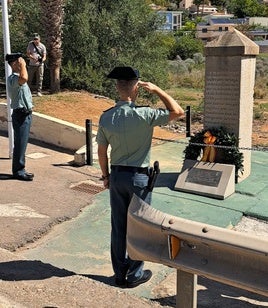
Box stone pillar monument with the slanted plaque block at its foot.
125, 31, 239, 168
175, 29, 259, 199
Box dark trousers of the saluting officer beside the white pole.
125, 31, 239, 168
12, 108, 32, 175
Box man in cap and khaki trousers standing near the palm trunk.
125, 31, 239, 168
27, 33, 47, 96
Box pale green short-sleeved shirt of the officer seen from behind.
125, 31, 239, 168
96, 101, 169, 167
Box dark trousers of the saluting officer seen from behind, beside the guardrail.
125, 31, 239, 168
110, 166, 152, 282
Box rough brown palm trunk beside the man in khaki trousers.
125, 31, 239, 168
40, 0, 64, 93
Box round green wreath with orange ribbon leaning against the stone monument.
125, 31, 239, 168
183, 127, 244, 182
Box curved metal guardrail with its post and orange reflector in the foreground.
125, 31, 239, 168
127, 195, 268, 308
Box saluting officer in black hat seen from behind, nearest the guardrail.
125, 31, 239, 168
96, 67, 184, 288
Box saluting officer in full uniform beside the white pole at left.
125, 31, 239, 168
6, 53, 34, 181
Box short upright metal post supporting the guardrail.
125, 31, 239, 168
176, 269, 197, 308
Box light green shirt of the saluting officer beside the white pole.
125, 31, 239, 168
7, 73, 33, 110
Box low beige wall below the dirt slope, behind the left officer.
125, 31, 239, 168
0, 103, 96, 151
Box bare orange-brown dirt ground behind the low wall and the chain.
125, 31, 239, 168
34, 91, 268, 146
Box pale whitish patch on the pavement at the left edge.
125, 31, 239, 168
0, 203, 49, 218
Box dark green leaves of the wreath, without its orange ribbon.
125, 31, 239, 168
183, 127, 244, 178
